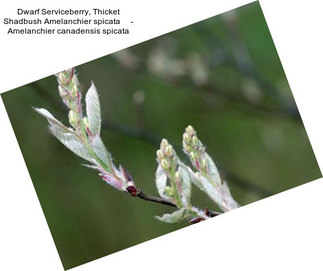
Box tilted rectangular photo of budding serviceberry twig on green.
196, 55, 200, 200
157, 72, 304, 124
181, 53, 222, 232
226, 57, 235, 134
1, 2, 322, 269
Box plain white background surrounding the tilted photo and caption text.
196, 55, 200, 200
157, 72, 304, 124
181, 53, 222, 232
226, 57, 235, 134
0, 0, 323, 270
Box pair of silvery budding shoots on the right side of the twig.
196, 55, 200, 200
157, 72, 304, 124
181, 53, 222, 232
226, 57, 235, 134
156, 125, 239, 223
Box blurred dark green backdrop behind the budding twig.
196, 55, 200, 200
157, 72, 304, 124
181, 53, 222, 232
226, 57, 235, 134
1, 2, 321, 269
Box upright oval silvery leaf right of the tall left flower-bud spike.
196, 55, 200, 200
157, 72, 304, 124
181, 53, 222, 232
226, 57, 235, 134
85, 82, 101, 135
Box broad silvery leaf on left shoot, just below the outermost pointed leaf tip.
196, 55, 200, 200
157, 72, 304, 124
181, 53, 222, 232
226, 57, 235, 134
49, 125, 93, 162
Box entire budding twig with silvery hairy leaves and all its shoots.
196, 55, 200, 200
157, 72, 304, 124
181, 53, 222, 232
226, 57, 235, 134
34, 68, 239, 223
